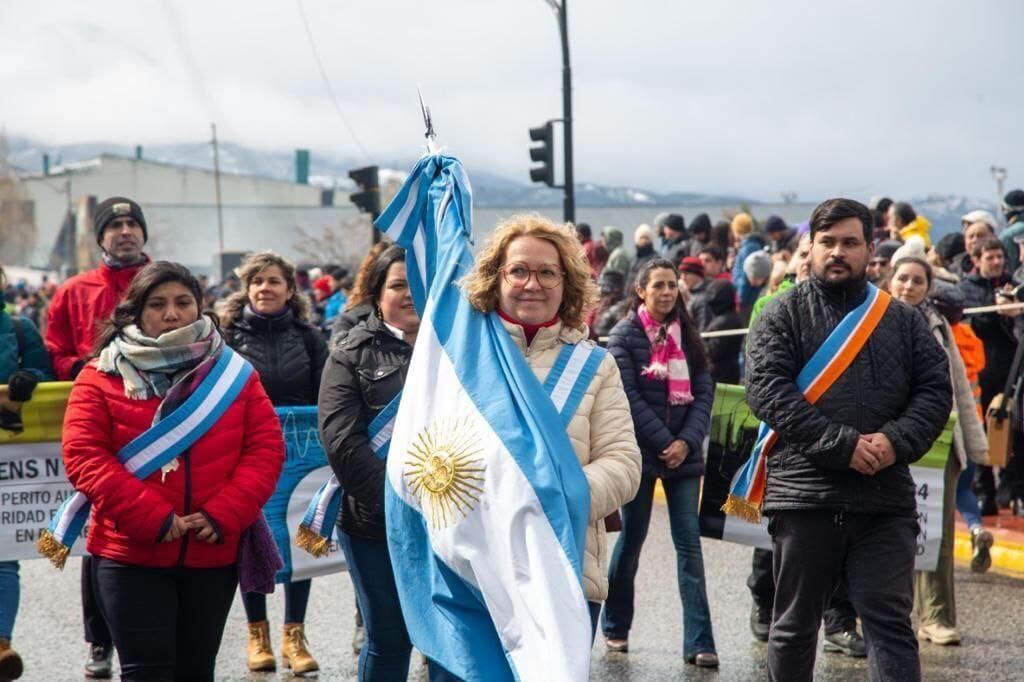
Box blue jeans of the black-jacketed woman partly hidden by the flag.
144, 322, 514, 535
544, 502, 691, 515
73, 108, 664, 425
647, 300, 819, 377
337, 528, 455, 682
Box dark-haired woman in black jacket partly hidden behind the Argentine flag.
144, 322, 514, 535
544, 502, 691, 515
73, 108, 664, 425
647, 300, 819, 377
319, 246, 446, 681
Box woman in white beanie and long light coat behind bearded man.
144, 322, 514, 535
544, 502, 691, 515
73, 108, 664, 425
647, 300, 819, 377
889, 256, 992, 645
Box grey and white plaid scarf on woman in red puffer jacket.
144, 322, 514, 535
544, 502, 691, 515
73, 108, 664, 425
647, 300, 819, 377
97, 315, 224, 403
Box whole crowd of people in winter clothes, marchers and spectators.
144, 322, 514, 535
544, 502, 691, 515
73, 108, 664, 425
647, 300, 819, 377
0, 190, 1024, 680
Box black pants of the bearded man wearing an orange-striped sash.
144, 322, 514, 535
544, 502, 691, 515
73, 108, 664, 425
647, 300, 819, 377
768, 510, 921, 682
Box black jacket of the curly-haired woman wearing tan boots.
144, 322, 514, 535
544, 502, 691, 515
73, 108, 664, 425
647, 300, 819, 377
224, 306, 327, 408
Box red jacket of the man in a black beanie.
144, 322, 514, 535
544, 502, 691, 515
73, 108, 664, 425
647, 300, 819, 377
46, 258, 150, 381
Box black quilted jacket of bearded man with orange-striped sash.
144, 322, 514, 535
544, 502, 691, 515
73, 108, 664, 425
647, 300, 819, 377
746, 276, 952, 514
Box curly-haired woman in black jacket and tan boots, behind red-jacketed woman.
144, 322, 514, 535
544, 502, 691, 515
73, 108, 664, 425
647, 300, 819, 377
218, 251, 327, 674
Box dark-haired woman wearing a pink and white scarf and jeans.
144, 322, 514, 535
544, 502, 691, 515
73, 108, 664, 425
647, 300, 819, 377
603, 258, 718, 668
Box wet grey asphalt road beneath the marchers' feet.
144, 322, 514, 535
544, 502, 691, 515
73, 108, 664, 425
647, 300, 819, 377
14, 497, 1024, 682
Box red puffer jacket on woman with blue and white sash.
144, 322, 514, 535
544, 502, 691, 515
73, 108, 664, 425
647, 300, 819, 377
63, 365, 285, 568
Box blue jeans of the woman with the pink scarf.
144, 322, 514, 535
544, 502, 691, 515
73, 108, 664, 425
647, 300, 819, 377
602, 475, 715, 660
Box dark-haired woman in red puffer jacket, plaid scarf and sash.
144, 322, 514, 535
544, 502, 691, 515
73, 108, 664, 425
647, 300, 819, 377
63, 261, 285, 680
